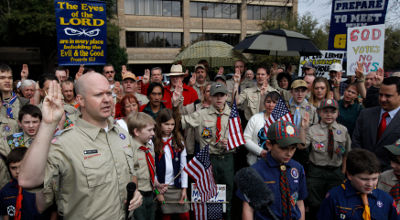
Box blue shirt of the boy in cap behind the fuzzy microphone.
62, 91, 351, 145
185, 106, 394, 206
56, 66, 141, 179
237, 152, 307, 220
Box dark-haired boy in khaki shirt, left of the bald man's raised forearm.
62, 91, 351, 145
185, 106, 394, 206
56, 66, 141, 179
0, 104, 42, 188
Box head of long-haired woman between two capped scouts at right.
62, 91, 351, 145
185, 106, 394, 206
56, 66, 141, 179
309, 77, 333, 108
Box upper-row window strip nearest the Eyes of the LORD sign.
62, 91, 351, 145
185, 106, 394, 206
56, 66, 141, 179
125, 0, 182, 17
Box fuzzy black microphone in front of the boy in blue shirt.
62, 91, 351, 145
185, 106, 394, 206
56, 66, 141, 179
235, 167, 279, 220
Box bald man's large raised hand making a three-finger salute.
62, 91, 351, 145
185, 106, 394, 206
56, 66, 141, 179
42, 81, 64, 125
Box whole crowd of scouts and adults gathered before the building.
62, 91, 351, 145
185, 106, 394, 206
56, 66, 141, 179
0, 60, 400, 220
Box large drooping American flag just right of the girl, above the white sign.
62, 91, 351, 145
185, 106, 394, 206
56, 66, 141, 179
183, 145, 217, 202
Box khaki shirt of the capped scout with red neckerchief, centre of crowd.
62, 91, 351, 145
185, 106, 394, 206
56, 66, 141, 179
182, 104, 231, 154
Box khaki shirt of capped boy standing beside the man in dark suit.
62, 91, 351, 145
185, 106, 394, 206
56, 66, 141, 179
306, 122, 351, 167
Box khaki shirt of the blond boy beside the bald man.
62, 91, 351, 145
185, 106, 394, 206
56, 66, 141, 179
132, 138, 156, 192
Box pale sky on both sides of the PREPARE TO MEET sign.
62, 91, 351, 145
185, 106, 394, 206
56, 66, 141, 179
298, 0, 400, 27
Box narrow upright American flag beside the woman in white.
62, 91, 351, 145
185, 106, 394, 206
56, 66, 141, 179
226, 101, 246, 150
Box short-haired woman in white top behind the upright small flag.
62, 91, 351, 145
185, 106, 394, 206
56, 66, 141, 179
244, 92, 280, 165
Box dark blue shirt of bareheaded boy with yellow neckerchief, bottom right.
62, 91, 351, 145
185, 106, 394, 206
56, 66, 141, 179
317, 181, 400, 220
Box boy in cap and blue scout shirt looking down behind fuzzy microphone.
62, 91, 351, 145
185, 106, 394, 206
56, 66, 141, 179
238, 121, 307, 220
